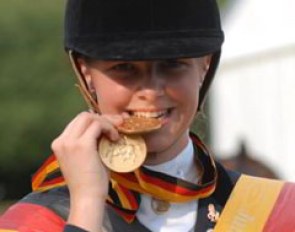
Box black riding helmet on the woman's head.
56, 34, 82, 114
64, 0, 224, 109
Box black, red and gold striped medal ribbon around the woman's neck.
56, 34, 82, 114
32, 133, 217, 222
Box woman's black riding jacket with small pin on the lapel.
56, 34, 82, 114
11, 163, 240, 232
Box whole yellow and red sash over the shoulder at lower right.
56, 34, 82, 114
214, 175, 295, 232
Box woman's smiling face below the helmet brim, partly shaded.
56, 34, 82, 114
79, 56, 211, 164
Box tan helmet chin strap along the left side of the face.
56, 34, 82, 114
69, 50, 100, 114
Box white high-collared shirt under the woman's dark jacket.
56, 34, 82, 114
136, 140, 198, 232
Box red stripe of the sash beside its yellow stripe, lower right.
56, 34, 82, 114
263, 183, 295, 232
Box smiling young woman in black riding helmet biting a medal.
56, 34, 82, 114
0, 0, 295, 232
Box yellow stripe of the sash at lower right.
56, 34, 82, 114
214, 175, 284, 232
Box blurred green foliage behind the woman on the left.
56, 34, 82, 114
0, 0, 84, 198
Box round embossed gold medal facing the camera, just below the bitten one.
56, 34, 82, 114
98, 135, 147, 172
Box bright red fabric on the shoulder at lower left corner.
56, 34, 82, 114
0, 203, 65, 232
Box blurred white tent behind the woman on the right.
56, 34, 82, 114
211, 0, 295, 181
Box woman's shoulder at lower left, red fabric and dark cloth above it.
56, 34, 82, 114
0, 187, 70, 232
